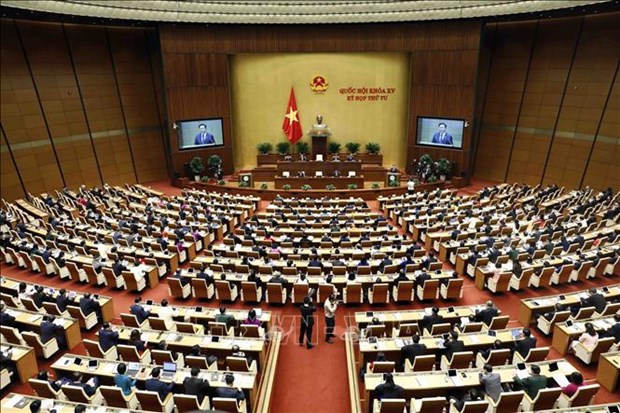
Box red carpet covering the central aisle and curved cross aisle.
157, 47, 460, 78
0, 181, 620, 413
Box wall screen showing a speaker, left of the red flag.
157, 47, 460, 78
176, 118, 224, 151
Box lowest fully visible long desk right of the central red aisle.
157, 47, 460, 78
364, 360, 578, 407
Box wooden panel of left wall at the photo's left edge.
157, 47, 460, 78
0, 20, 64, 200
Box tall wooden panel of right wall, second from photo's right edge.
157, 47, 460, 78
543, 12, 620, 187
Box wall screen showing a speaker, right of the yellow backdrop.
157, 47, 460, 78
416, 116, 465, 149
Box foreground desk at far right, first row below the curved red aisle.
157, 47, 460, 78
518, 284, 620, 327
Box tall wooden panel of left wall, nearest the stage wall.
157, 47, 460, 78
108, 27, 168, 182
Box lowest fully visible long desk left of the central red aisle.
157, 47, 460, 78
51, 354, 258, 404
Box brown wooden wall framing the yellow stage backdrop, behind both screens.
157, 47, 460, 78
159, 21, 481, 173
